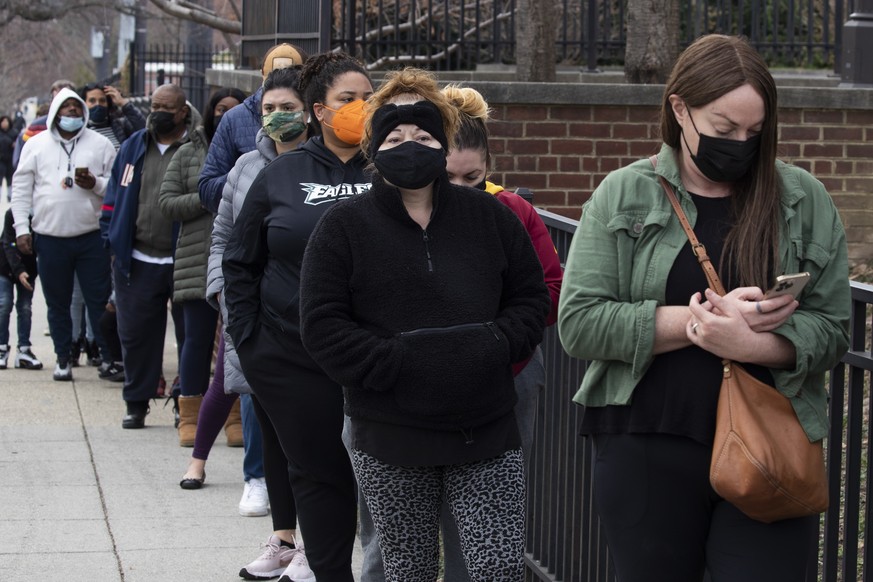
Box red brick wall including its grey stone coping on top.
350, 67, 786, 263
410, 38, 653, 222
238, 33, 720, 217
207, 70, 873, 264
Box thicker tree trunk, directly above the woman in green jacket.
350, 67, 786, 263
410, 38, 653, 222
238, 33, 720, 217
624, 0, 679, 84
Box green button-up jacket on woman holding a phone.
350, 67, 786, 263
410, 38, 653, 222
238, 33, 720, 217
558, 146, 851, 441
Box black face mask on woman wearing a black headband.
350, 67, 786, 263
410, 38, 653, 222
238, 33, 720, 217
373, 141, 446, 190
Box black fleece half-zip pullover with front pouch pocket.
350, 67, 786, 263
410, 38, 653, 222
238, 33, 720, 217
300, 174, 551, 431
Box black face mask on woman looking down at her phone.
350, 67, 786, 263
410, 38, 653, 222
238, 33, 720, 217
682, 113, 761, 182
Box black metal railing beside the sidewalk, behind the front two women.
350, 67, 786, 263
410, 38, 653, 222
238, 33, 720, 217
525, 210, 873, 582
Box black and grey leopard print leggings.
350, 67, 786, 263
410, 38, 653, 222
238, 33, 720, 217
352, 449, 525, 582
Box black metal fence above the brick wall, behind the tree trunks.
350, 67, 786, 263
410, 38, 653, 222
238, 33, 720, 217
331, 0, 854, 72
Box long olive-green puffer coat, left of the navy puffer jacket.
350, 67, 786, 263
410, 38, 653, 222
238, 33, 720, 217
159, 127, 212, 302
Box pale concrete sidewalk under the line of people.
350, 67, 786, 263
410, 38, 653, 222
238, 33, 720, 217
0, 196, 360, 582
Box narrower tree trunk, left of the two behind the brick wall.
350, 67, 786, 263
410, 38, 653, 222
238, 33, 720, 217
515, 0, 557, 82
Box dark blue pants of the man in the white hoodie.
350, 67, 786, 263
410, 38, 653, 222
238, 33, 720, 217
34, 230, 112, 361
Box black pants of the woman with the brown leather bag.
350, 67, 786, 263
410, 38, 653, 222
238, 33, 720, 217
594, 434, 819, 582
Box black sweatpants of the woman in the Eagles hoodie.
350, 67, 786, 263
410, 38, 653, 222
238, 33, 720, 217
237, 325, 357, 582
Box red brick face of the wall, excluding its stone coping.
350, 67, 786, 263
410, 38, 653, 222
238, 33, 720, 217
474, 85, 873, 264
